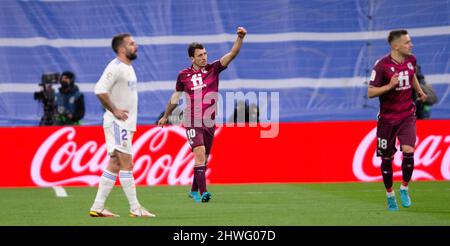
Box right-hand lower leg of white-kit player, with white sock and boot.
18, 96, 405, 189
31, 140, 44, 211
114, 150, 155, 217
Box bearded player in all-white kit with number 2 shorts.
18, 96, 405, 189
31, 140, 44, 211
89, 33, 155, 217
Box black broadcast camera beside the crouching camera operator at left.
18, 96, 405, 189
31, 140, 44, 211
33, 73, 59, 126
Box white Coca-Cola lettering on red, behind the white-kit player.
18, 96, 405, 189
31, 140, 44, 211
31, 126, 220, 187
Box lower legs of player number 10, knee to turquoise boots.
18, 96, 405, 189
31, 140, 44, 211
191, 145, 211, 202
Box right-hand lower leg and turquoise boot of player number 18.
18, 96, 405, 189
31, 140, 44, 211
400, 145, 414, 208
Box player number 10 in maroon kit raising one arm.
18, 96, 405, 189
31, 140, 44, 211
158, 27, 247, 202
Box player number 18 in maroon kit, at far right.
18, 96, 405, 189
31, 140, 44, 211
368, 30, 427, 211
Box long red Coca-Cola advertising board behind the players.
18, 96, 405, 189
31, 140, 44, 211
0, 120, 450, 187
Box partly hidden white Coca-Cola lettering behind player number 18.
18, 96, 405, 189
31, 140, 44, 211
353, 128, 450, 181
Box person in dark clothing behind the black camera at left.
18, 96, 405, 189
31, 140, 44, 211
56, 71, 84, 125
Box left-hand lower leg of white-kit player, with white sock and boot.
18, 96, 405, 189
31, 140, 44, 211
89, 153, 120, 217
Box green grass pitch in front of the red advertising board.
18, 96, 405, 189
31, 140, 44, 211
0, 182, 450, 226
